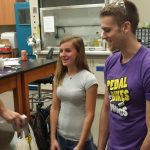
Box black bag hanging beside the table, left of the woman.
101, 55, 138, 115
30, 105, 51, 150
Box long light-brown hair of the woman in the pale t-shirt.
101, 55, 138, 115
55, 36, 90, 86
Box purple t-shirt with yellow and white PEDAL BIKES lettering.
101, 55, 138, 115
105, 46, 150, 150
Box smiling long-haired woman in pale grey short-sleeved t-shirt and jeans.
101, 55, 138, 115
51, 36, 98, 150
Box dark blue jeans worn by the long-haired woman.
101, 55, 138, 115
57, 134, 97, 150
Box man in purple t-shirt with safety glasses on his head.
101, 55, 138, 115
98, 0, 150, 150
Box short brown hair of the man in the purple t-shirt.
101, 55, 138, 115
100, 0, 139, 34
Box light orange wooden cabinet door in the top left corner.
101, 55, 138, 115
0, 0, 15, 25
